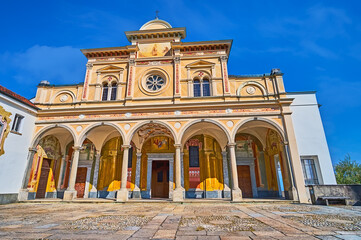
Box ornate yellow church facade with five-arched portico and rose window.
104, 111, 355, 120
14, 19, 334, 202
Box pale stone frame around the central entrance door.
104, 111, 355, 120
147, 153, 174, 199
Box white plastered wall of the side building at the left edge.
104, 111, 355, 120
0, 93, 36, 194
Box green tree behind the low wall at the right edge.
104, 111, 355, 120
335, 154, 361, 184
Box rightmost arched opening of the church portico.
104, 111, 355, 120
235, 120, 291, 199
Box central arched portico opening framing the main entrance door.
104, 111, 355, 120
128, 123, 175, 198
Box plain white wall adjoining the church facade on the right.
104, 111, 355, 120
287, 92, 336, 184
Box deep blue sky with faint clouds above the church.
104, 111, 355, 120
0, 0, 361, 162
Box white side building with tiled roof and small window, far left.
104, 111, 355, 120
0, 86, 38, 203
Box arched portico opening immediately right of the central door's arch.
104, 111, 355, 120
182, 122, 230, 198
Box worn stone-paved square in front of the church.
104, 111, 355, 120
0, 202, 361, 240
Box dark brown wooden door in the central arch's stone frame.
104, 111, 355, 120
152, 161, 169, 198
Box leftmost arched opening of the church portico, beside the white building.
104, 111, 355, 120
26, 126, 74, 199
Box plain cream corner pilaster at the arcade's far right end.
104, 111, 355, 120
283, 110, 309, 203
